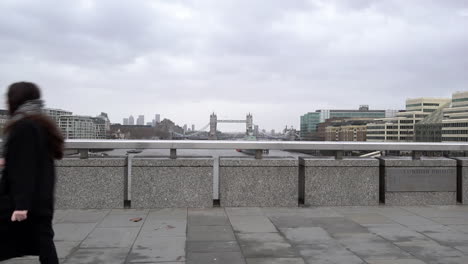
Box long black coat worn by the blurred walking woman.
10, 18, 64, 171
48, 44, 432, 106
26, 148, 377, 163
0, 118, 55, 261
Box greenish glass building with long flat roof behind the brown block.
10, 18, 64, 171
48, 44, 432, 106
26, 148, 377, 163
301, 105, 385, 140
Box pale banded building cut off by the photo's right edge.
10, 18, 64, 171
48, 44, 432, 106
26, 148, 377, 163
442, 91, 468, 142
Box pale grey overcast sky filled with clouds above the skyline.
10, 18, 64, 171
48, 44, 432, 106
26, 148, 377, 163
0, 0, 468, 131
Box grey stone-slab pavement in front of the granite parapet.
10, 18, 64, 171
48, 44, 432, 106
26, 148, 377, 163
5, 206, 468, 264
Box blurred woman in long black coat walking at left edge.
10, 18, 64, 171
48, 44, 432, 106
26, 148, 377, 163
0, 82, 64, 264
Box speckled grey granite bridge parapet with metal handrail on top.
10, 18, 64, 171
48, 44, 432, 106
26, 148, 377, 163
56, 140, 468, 208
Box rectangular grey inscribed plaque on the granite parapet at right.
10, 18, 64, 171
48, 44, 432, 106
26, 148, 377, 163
385, 167, 457, 192
